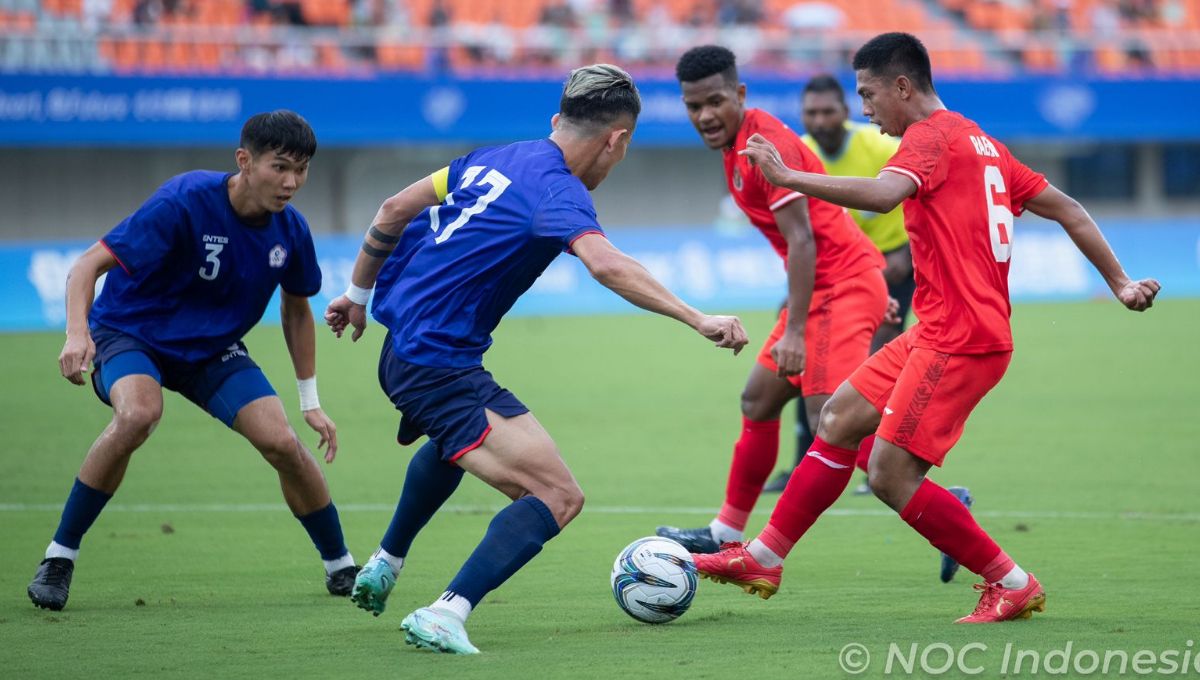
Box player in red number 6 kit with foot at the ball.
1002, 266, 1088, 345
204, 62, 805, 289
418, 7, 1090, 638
696, 34, 1159, 624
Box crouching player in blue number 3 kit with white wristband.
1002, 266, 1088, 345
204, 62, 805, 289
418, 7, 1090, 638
29, 110, 358, 610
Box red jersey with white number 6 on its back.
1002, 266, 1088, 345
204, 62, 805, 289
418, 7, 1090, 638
882, 110, 1046, 354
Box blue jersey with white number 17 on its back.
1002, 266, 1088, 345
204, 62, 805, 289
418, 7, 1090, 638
373, 139, 604, 368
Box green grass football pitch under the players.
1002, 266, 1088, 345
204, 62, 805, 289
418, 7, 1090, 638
0, 300, 1200, 679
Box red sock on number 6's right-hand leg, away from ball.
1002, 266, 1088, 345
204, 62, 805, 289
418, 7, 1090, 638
900, 479, 1013, 582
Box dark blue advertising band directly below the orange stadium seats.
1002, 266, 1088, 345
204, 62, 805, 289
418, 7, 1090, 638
0, 76, 1200, 146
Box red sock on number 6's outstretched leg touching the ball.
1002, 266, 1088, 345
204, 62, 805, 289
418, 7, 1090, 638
758, 437, 858, 558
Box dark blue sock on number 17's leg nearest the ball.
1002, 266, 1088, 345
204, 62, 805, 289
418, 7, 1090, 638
446, 495, 558, 607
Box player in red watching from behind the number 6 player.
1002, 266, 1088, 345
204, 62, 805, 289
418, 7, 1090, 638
658, 46, 894, 553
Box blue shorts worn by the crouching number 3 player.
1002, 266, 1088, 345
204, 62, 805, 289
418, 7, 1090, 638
91, 326, 275, 427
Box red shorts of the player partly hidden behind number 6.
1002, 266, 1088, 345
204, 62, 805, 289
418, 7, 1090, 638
758, 269, 888, 397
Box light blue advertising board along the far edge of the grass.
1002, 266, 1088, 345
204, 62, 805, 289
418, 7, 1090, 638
0, 218, 1200, 331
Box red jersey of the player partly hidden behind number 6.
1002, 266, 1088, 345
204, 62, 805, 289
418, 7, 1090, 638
725, 109, 884, 288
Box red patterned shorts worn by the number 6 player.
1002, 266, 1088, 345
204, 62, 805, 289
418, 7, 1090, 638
850, 324, 1013, 465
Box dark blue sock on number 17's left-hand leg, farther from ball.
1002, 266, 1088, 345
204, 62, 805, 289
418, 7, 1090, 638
379, 441, 463, 558
